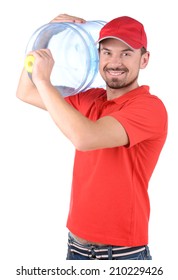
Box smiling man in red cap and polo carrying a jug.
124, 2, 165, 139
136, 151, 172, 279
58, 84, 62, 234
17, 12, 167, 260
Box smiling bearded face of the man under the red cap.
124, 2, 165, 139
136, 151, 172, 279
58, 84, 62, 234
99, 39, 149, 97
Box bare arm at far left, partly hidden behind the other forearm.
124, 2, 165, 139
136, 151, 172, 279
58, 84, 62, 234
16, 69, 46, 110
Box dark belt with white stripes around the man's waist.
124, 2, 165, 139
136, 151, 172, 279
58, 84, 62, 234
68, 235, 145, 260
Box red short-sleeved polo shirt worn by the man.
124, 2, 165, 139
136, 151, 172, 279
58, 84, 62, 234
66, 86, 167, 246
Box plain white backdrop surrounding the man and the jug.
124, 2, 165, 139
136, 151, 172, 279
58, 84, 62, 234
0, 0, 178, 280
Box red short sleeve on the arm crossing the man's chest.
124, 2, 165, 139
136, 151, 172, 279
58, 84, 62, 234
111, 95, 167, 147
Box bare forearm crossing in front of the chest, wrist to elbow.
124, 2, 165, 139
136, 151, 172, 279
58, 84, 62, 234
36, 81, 94, 150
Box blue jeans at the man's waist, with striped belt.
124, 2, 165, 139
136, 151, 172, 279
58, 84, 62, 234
66, 234, 152, 260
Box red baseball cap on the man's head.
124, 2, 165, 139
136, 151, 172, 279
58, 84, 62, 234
98, 16, 147, 49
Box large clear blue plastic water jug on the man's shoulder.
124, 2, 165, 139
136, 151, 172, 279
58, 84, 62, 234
26, 20, 106, 97
